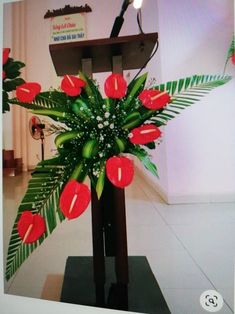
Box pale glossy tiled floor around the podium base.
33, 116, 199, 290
3, 174, 235, 314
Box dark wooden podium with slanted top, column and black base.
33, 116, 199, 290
49, 33, 170, 314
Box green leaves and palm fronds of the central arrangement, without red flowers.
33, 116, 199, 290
3, 73, 230, 280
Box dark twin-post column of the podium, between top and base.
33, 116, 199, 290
82, 55, 129, 310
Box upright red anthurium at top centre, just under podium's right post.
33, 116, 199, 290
104, 74, 127, 99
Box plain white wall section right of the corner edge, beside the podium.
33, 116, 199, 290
155, 0, 235, 202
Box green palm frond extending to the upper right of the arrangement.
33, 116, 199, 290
149, 75, 231, 126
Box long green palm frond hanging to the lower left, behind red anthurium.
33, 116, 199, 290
6, 163, 68, 280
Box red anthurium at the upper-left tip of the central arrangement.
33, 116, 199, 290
16, 82, 41, 103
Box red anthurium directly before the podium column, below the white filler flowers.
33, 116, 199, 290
106, 156, 134, 188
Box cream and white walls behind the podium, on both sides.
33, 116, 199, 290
2, 0, 235, 202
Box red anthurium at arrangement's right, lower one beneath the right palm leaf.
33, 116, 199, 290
129, 124, 161, 144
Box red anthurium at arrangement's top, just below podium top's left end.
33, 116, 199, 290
60, 75, 86, 96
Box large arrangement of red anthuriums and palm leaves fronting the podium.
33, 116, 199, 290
3, 47, 230, 280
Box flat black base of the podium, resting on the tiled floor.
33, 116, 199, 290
60, 256, 170, 314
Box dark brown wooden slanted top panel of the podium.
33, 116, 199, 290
49, 33, 158, 75
